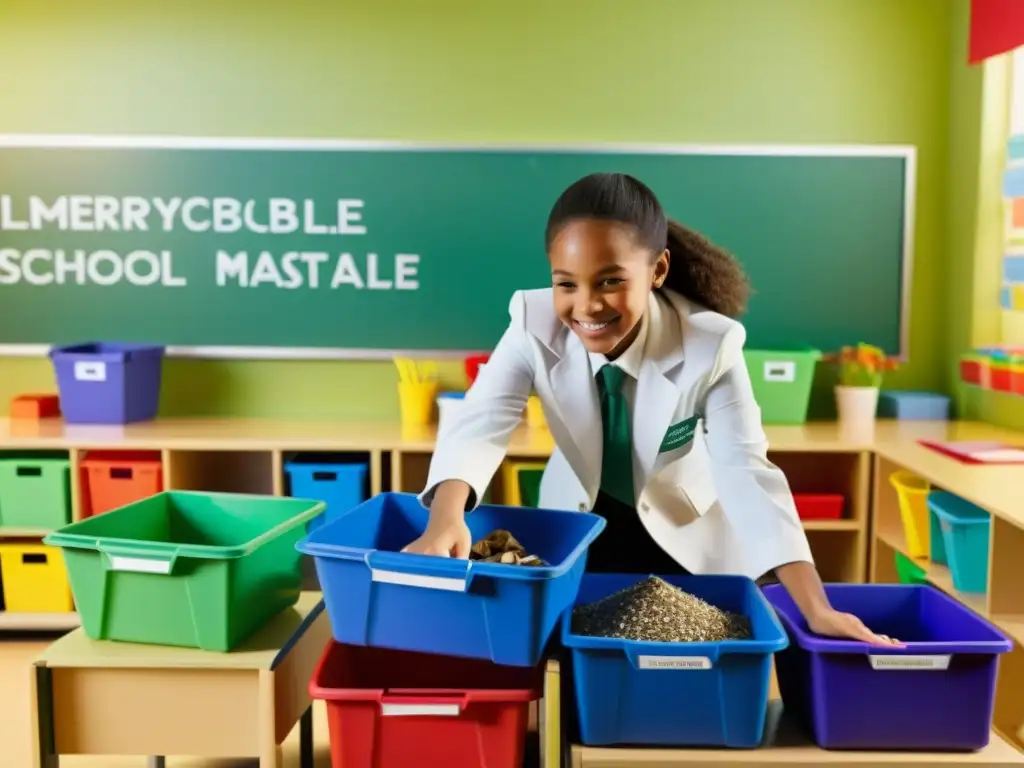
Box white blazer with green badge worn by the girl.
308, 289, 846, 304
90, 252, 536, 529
420, 288, 813, 579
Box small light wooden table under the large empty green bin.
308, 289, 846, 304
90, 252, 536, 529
30, 592, 331, 768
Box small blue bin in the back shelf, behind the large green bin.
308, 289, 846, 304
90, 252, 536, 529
285, 455, 370, 531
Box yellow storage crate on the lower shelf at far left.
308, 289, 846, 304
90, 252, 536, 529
0, 541, 75, 613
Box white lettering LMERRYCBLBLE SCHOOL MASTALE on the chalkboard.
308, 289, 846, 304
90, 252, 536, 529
0, 195, 420, 291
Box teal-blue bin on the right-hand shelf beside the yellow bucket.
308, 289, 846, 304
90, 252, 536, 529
928, 490, 992, 594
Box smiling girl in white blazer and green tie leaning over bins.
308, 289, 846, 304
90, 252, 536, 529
406, 173, 896, 644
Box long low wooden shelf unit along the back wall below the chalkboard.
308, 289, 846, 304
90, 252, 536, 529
0, 419, 871, 631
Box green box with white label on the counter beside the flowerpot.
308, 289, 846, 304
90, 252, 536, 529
743, 349, 821, 424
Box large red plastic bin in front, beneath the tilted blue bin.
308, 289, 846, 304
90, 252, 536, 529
309, 640, 543, 768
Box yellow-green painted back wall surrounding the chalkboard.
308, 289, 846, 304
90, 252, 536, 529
0, 0, 952, 419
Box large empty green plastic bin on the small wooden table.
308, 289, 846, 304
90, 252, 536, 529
44, 490, 326, 651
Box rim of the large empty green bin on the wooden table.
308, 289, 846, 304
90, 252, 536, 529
43, 490, 327, 560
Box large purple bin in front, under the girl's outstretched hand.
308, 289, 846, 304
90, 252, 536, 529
764, 584, 1013, 752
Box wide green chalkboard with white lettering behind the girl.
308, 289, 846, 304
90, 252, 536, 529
0, 137, 913, 357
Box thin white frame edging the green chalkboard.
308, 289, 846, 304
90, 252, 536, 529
0, 134, 918, 361
